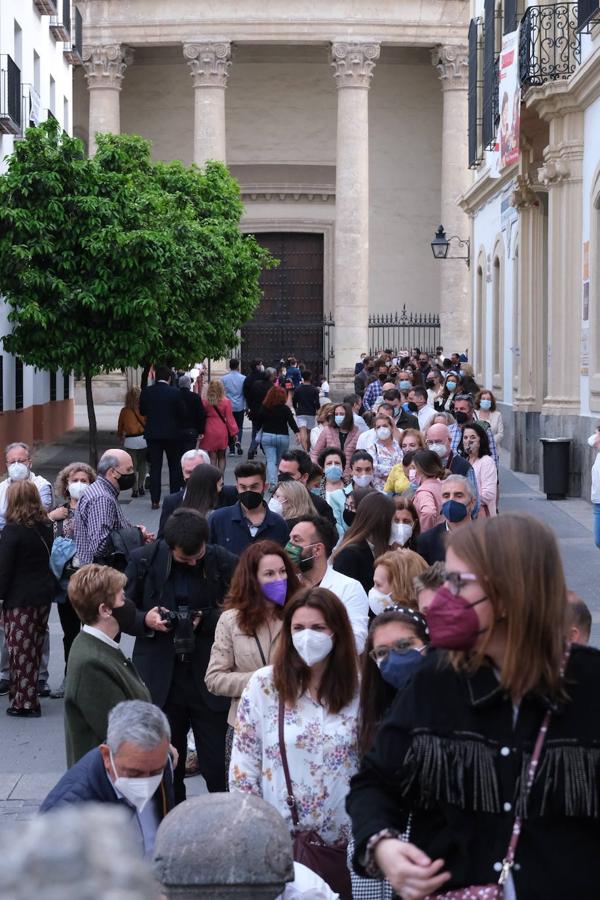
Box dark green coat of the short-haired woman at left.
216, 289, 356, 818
65, 631, 152, 768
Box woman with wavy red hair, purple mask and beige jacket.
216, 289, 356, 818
204, 541, 300, 769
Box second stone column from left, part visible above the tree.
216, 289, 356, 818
183, 41, 231, 166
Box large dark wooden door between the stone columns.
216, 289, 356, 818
242, 233, 324, 375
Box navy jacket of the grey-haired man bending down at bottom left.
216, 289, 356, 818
40, 747, 175, 821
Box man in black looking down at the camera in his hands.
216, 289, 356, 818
125, 509, 237, 803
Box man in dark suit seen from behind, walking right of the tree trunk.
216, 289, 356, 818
140, 366, 185, 509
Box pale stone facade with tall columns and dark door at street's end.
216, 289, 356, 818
74, 0, 470, 383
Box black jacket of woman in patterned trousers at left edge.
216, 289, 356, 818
0, 522, 58, 609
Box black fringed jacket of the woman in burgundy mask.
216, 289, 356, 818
347, 646, 600, 900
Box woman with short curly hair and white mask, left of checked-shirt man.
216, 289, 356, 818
48, 462, 96, 699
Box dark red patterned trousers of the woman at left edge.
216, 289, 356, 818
2, 604, 49, 712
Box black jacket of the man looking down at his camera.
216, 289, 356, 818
125, 541, 237, 711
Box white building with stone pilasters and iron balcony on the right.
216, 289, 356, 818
461, 0, 600, 496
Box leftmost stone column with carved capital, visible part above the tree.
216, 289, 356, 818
83, 44, 133, 156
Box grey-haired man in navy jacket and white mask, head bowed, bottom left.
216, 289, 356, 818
40, 700, 175, 857
